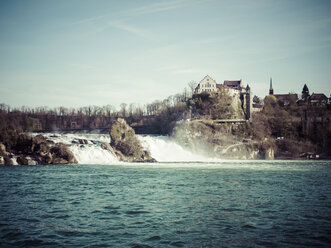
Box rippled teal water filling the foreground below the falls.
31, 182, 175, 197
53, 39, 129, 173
0, 161, 331, 247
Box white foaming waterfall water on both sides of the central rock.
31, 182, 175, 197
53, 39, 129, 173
34, 133, 216, 164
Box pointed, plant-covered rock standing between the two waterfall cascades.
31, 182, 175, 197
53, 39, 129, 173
109, 118, 155, 162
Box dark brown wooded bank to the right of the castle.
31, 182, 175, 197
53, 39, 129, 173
250, 95, 331, 158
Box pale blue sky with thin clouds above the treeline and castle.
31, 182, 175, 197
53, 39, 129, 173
0, 0, 331, 107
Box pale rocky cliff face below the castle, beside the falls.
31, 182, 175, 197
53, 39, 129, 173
172, 121, 274, 159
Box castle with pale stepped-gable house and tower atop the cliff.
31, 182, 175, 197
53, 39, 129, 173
194, 75, 252, 120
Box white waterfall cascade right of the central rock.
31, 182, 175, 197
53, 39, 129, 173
138, 135, 215, 162
